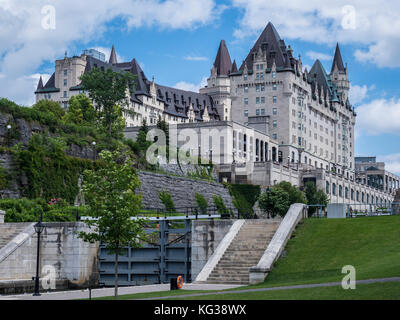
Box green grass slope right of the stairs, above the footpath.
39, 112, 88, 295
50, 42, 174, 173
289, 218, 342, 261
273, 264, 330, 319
245, 216, 400, 287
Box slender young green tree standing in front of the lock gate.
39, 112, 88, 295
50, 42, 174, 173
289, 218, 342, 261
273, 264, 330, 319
79, 150, 145, 299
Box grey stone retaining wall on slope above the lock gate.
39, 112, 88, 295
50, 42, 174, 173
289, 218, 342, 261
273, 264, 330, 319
138, 172, 233, 209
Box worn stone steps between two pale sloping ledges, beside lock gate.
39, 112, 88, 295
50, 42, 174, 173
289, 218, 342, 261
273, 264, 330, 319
206, 220, 280, 284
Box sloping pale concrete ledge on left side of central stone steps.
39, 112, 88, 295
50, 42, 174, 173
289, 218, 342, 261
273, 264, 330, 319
195, 220, 245, 283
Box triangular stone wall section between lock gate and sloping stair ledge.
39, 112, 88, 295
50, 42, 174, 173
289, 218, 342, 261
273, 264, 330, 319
192, 220, 235, 281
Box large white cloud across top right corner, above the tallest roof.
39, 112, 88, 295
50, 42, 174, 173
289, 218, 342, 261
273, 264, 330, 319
233, 0, 400, 67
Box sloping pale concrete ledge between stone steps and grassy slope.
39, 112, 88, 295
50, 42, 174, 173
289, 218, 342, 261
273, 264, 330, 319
249, 204, 307, 284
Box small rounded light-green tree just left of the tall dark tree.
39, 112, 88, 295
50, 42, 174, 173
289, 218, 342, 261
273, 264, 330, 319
63, 93, 96, 125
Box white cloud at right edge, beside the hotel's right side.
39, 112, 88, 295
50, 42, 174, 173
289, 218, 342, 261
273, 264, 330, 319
356, 98, 400, 135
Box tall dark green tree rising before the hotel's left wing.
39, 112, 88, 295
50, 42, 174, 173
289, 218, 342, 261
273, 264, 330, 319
81, 68, 136, 137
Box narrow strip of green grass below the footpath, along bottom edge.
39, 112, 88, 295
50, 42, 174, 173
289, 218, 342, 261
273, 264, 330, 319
171, 282, 400, 300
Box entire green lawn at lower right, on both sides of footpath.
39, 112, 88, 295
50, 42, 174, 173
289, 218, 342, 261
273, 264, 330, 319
90, 216, 400, 300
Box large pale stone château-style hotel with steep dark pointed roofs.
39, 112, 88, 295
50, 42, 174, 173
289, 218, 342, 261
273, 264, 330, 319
35, 23, 400, 207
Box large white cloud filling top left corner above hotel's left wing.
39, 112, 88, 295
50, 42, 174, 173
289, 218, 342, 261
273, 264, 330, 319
0, 0, 222, 103
